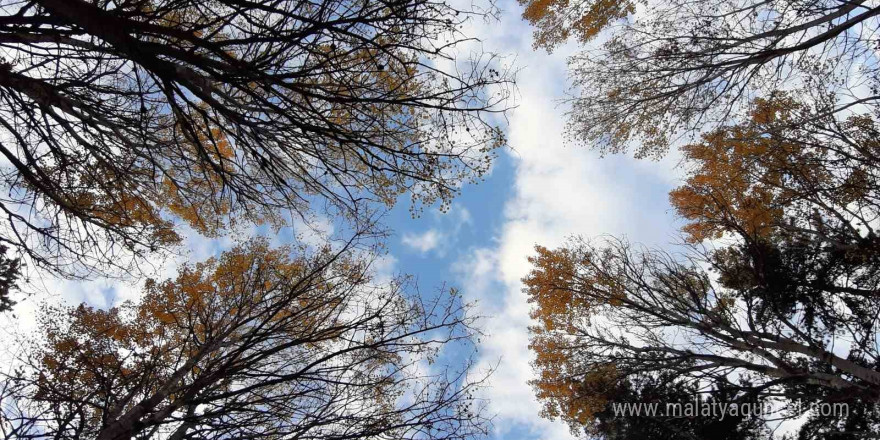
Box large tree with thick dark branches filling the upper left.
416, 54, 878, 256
0, 0, 511, 277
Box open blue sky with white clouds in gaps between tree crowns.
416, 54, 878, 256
0, 0, 680, 440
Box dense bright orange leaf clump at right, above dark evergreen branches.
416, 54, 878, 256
669, 94, 829, 242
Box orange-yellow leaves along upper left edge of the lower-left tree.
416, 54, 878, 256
31, 240, 340, 428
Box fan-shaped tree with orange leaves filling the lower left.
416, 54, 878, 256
0, 241, 487, 440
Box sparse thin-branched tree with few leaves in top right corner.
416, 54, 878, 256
521, 0, 880, 157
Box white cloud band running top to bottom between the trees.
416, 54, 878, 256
452, 1, 677, 439
